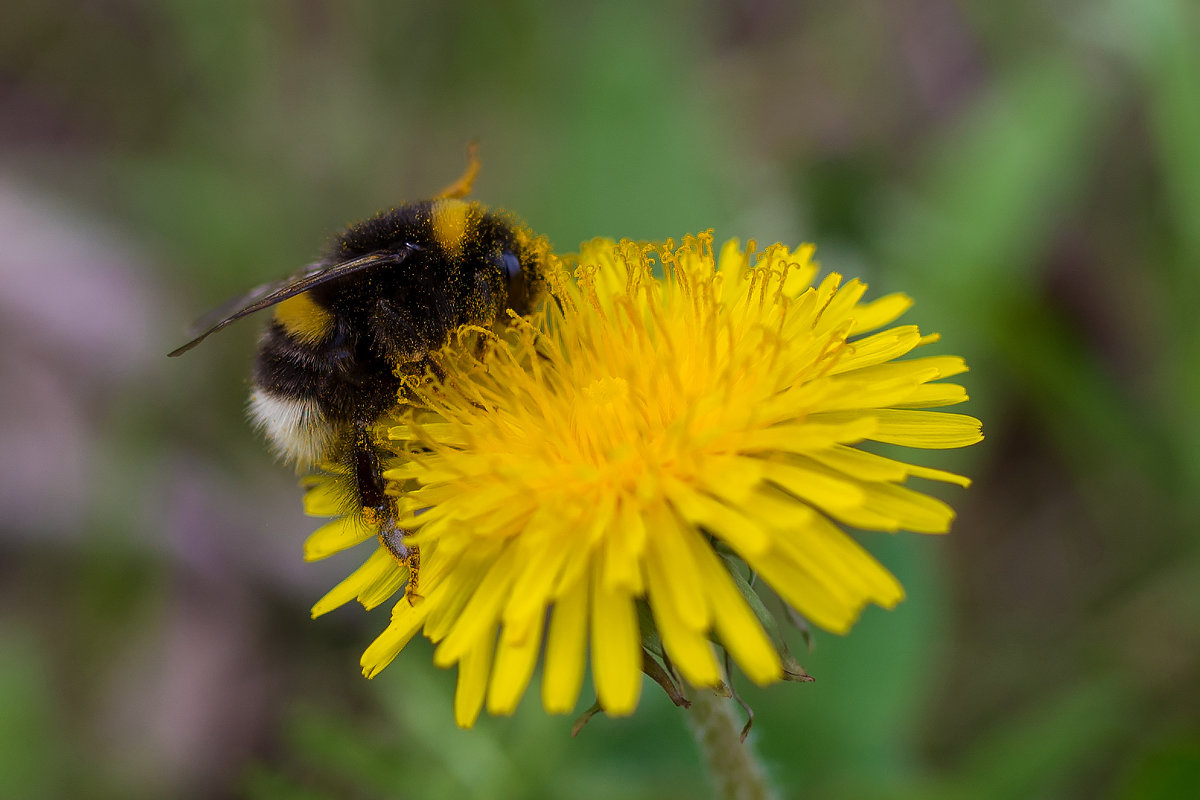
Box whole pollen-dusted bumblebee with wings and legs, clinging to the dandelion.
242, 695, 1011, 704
170, 154, 550, 602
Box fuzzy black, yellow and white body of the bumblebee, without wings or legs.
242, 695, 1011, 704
241, 199, 542, 467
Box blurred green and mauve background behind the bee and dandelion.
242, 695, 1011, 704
0, 0, 1200, 800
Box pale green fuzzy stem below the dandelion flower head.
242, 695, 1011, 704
690, 688, 776, 800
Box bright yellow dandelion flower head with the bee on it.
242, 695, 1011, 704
308, 235, 982, 726
